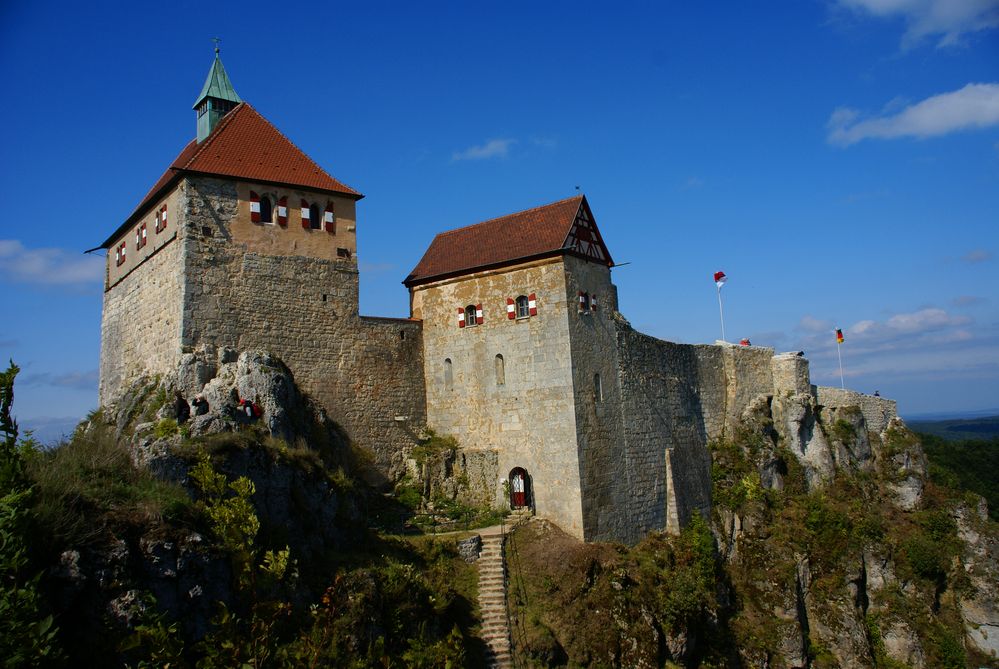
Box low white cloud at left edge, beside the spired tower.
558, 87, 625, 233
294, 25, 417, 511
0, 239, 104, 286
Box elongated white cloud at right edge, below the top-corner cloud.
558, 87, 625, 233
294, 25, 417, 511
826, 83, 999, 146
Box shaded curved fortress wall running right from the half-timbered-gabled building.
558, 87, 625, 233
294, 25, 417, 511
581, 314, 897, 542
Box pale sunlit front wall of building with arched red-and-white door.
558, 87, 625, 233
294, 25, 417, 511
411, 259, 583, 538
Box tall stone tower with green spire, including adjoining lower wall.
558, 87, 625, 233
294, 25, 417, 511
94, 53, 425, 471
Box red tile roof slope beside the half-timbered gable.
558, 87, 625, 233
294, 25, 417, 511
403, 195, 608, 286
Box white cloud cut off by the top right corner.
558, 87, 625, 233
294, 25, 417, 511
839, 0, 999, 47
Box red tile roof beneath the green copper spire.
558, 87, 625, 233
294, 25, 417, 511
102, 102, 364, 248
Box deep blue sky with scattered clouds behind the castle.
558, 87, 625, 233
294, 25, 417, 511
0, 0, 999, 430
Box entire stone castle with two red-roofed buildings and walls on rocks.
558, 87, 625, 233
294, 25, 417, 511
100, 53, 895, 542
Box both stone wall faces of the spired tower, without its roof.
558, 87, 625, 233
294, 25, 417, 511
101, 172, 426, 476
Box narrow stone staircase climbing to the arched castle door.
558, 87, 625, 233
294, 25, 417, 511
478, 528, 513, 669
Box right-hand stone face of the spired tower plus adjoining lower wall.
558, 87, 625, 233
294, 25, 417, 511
182, 178, 426, 475
